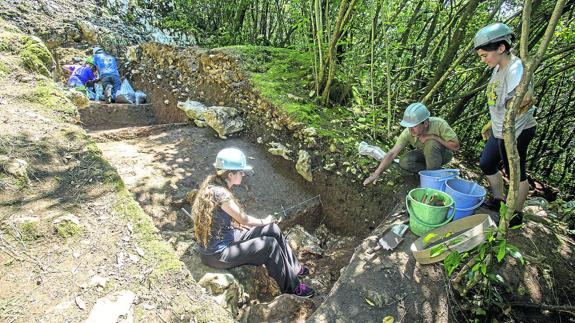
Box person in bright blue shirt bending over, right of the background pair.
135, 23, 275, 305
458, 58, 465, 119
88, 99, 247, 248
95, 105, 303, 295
93, 47, 121, 103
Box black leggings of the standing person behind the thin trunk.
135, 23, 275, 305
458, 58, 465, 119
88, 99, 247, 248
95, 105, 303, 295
479, 127, 536, 182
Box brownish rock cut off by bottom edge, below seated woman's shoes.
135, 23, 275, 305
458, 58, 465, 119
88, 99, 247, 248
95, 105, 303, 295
240, 294, 315, 322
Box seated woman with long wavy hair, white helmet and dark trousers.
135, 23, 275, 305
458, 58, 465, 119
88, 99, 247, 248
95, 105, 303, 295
192, 148, 315, 297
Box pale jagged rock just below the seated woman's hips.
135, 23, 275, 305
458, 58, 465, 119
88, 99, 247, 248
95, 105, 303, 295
198, 273, 244, 315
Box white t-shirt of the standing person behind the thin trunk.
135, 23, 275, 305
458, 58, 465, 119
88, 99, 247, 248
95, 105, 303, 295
487, 55, 537, 139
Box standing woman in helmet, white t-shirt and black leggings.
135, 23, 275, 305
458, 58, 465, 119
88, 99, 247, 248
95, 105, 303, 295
474, 23, 537, 226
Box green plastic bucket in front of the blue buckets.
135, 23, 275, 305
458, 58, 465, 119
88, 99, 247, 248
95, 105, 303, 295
405, 188, 455, 225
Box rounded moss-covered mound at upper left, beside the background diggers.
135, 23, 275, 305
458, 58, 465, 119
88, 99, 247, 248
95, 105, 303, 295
20, 37, 54, 76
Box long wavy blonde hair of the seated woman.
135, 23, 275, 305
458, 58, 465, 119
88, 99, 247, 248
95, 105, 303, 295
192, 170, 235, 248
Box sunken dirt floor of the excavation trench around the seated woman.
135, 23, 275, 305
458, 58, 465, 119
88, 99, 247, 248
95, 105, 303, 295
80, 103, 376, 306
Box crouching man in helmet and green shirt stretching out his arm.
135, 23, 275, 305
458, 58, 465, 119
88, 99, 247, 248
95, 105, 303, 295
363, 102, 459, 186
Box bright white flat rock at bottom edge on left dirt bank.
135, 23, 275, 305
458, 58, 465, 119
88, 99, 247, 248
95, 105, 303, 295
86, 290, 136, 323
